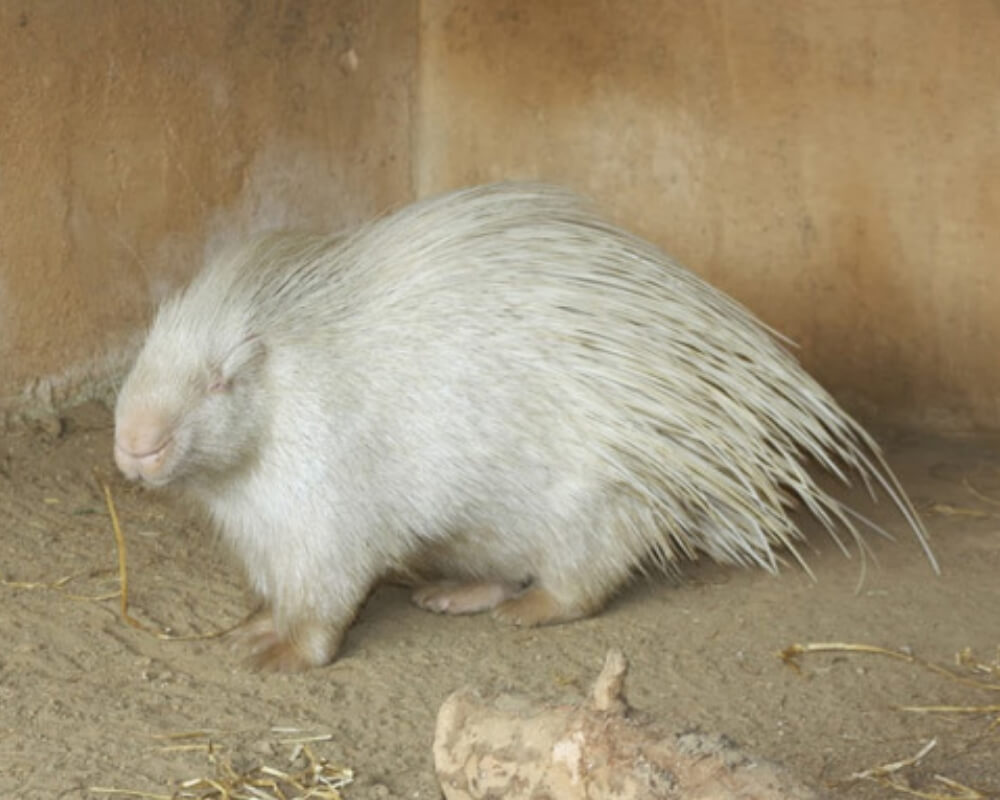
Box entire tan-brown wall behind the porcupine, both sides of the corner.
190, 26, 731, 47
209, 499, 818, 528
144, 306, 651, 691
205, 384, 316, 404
0, 0, 1000, 429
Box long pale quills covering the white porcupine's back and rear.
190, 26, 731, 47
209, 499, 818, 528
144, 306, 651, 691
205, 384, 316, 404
316, 184, 934, 570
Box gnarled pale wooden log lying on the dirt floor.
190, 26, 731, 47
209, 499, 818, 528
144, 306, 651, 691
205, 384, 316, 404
434, 651, 820, 800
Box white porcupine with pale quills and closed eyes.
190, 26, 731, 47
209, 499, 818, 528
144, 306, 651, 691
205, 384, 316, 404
116, 184, 929, 663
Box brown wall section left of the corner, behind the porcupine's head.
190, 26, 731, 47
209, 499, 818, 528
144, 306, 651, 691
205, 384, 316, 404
0, 0, 417, 417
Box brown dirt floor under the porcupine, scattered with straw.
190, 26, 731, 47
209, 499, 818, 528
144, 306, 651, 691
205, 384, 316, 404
0, 406, 1000, 800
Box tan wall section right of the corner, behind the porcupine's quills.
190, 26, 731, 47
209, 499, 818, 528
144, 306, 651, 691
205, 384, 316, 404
417, 0, 1000, 428
